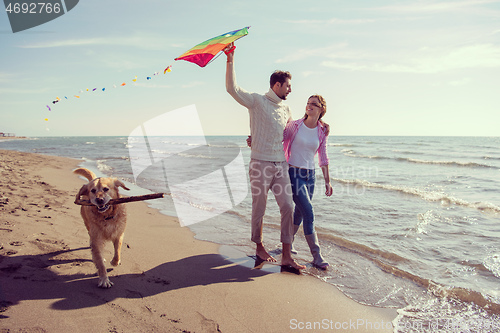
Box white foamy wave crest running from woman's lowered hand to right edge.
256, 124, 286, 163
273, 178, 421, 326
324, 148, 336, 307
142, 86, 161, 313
332, 178, 500, 213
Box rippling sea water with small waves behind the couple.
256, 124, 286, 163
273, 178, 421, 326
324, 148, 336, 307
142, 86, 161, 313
0, 136, 500, 332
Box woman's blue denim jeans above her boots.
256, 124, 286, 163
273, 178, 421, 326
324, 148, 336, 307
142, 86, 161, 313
288, 167, 316, 235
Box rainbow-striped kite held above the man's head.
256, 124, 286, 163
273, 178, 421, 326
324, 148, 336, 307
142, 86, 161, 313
175, 27, 250, 67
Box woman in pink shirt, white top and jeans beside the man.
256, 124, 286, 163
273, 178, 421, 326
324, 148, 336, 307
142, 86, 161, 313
283, 95, 333, 269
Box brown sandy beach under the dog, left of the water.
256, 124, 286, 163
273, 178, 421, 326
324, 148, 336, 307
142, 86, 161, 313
0, 150, 397, 333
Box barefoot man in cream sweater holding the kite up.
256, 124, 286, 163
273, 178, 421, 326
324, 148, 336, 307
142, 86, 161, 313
226, 44, 305, 269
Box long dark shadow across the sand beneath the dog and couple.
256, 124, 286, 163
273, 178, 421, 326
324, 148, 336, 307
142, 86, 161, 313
0, 248, 281, 312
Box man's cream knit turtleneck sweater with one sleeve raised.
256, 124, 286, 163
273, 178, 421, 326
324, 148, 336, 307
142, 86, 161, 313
226, 62, 291, 162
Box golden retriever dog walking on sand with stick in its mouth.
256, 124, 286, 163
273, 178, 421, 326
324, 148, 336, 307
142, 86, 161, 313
73, 168, 129, 288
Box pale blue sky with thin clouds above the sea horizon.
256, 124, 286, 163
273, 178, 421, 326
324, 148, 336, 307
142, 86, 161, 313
0, 0, 500, 137
